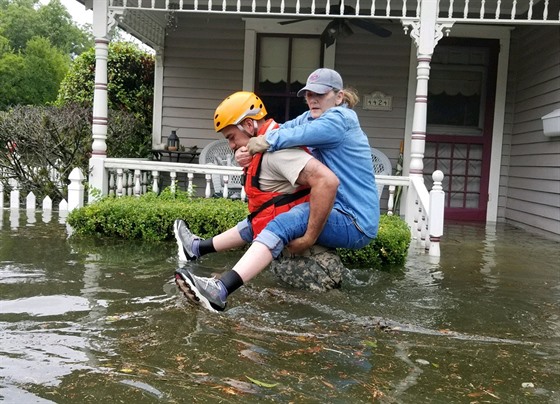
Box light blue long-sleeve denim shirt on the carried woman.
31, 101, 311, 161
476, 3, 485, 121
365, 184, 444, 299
266, 106, 379, 238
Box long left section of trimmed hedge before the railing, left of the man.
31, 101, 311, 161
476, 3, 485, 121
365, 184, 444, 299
67, 190, 248, 241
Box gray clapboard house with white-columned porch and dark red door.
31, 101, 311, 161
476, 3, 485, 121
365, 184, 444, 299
80, 0, 560, 243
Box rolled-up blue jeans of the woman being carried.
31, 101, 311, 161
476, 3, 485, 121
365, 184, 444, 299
252, 203, 372, 258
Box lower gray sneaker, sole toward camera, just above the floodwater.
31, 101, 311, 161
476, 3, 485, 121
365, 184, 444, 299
175, 269, 227, 312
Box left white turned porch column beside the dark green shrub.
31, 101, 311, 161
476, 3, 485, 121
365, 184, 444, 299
88, 0, 109, 203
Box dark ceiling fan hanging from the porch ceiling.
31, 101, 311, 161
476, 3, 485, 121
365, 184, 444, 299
279, 4, 392, 48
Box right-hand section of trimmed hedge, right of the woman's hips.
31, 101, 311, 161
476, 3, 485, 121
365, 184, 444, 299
337, 215, 411, 268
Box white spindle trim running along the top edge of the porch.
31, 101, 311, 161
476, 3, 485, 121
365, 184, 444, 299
109, 0, 560, 24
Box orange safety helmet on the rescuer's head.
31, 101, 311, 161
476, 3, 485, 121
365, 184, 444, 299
214, 91, 267, 132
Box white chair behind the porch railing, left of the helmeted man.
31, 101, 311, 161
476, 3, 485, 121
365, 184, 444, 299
198, 139, 243, 198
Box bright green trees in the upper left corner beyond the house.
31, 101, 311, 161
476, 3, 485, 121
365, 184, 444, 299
0, 0, 93, 110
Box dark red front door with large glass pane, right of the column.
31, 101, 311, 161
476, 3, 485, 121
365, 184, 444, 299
424, 38, 499, 221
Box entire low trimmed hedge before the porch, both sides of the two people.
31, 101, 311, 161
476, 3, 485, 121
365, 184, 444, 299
68, 189, 410, 269
